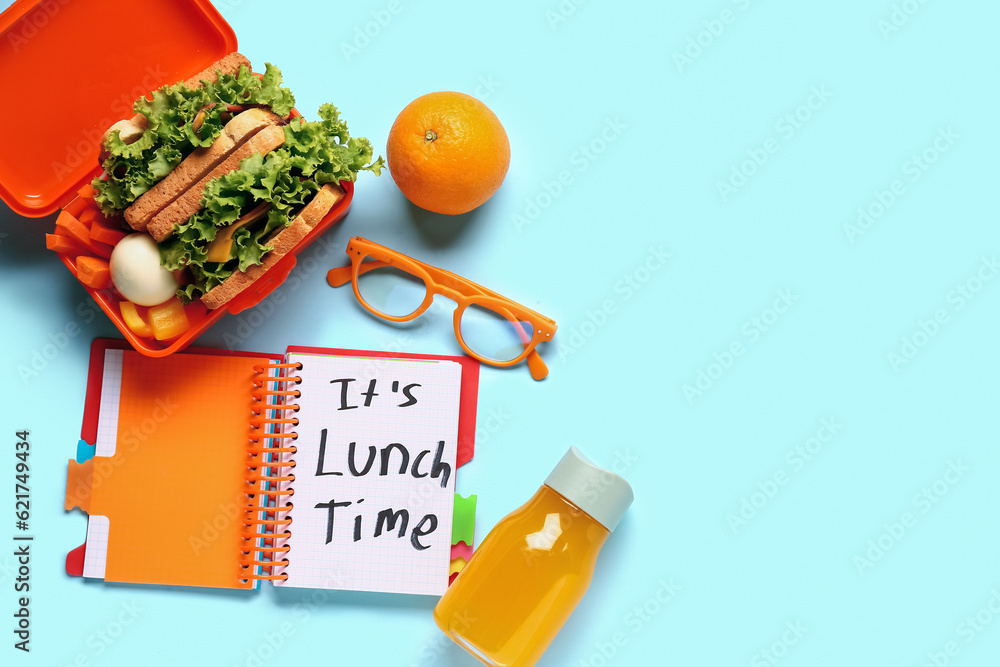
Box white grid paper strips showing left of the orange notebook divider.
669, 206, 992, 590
83, 350, 122, 579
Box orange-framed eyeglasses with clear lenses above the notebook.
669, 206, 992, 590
326, 236, 557, 380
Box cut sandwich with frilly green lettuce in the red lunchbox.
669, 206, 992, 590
92, 53, 384, 309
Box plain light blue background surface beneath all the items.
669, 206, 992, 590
0, 0, 1000, 667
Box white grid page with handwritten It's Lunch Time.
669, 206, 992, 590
276, 353, 462, 595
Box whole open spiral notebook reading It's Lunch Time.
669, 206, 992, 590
66, 339, 479, 595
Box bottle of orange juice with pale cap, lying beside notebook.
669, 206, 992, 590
434, 447, 633, 667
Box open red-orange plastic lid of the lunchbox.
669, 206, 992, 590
0, 0, 236, 217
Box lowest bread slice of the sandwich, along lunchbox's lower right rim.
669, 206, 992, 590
201, 183, 346, 310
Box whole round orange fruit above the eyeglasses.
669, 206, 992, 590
385, 92, 510, 215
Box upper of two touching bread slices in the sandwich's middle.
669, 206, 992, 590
125, 109, 281, 232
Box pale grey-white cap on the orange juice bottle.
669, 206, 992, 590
545, 447, 634, 531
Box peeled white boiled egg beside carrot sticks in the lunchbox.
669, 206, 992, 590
111, 234, 177, 306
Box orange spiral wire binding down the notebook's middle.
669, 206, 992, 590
240, 363, 302, 584
